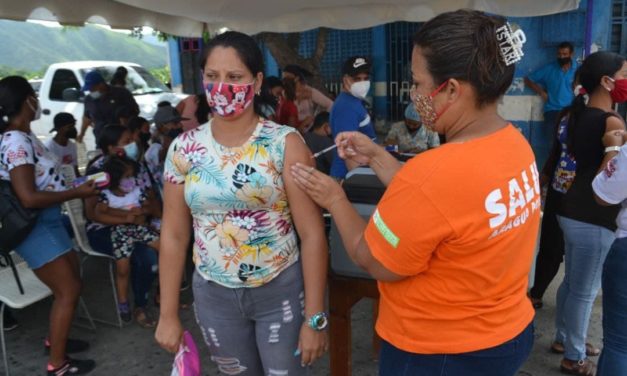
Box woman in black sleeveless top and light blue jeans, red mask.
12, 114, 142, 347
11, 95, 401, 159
551, 52, 627, 375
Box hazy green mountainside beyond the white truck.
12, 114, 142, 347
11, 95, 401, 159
0, 20, 168, 72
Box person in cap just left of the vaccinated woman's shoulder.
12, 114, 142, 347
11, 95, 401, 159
144, 104, 189, 189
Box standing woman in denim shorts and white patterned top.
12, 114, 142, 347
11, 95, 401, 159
0, 76, 98, 376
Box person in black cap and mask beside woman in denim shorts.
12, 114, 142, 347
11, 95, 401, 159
46, 112, 78, 176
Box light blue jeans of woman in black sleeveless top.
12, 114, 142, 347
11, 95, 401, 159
555, 216, 614, 361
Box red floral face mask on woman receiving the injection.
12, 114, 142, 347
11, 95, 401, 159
203, 82, 255, 117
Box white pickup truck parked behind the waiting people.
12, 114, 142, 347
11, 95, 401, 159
31, 61, 185, 150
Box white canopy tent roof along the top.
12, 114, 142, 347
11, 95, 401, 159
0, 0, 579, 37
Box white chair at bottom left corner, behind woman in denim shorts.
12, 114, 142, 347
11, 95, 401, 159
0, 252, 52, 376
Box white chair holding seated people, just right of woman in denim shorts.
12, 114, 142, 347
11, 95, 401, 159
61, 165, 123, 328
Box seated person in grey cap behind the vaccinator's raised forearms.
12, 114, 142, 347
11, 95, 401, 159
385, 103, 440, 154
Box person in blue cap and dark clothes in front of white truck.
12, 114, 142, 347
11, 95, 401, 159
76, 70, 139, 142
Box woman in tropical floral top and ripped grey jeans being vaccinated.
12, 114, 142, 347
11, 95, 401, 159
156, 31, 328, 375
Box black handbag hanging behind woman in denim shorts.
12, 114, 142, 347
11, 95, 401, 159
0, 135, 39, 254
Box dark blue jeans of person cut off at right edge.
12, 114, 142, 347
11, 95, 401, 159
597, 238, 627, 376
